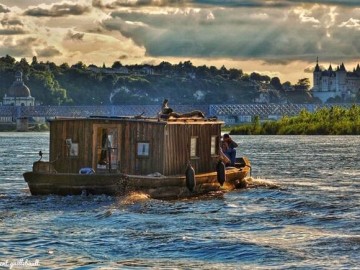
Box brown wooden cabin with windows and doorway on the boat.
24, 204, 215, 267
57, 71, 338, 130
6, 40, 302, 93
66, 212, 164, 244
50, 117, 223, 175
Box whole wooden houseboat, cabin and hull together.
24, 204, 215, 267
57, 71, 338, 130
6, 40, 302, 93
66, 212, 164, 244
24, 113, 251, 199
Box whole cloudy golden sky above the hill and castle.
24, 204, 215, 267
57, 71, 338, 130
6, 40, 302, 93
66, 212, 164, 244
0, 0, 360, 83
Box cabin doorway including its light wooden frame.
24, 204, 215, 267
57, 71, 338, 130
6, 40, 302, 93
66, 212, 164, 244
93, 125, 120, 173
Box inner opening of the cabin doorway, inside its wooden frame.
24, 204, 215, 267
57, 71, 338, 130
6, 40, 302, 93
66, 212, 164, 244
96, 128, 118, 170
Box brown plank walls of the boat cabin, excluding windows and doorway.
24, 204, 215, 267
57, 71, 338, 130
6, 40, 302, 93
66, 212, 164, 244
50, 119, 221, 175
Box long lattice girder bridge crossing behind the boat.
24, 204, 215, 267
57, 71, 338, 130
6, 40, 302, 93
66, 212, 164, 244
0, 103, 358, 121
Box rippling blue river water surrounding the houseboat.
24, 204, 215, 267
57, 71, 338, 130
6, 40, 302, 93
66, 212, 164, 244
0, 133, 360, 269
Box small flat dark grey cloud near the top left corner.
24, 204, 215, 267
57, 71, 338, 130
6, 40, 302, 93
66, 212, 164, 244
24, 3, 90, 17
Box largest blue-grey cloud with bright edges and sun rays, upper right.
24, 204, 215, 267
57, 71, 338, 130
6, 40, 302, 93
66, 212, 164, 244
95, 1, 360, 64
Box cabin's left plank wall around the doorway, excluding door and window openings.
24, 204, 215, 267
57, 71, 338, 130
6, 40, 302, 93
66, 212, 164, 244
50, 119, 165, 174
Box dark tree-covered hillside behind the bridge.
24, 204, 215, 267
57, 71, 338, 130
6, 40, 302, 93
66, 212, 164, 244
0, 55, 311, 105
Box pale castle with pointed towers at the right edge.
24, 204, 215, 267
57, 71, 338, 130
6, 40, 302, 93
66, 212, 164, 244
312, 60, 360, 102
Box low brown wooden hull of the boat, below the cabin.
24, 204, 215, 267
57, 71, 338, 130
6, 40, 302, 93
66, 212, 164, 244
24, 163, 250, 199
